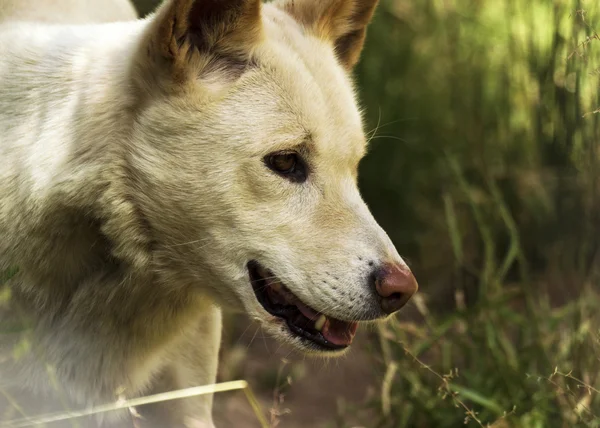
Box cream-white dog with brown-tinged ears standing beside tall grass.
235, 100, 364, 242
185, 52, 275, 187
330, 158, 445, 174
0, 0, 418, 427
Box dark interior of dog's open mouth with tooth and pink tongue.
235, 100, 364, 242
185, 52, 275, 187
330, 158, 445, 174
248, 261, 358, 351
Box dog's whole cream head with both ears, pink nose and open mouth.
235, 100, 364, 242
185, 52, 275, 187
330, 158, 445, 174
131, 0, 417, 353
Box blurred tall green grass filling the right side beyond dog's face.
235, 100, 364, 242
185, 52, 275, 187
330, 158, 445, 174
344, 0, 600, 427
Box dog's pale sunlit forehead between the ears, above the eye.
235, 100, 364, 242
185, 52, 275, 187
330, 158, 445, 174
259, 4, 366, 162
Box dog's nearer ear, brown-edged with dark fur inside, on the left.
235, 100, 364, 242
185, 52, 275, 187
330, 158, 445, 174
146, 0, 262, 81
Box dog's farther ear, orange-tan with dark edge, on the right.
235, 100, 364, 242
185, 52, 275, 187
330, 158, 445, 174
276, 0, 378, 70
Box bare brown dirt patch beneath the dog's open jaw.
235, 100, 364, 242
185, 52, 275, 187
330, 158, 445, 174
214, 321, 383, 428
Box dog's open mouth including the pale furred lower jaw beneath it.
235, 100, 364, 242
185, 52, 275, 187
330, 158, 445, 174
248, 261, 358, 356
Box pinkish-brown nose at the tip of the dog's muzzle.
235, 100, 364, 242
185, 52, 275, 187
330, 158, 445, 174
375, 263, 419, 314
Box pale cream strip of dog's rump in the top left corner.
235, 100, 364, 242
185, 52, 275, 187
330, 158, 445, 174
0, 0, 137, 24
